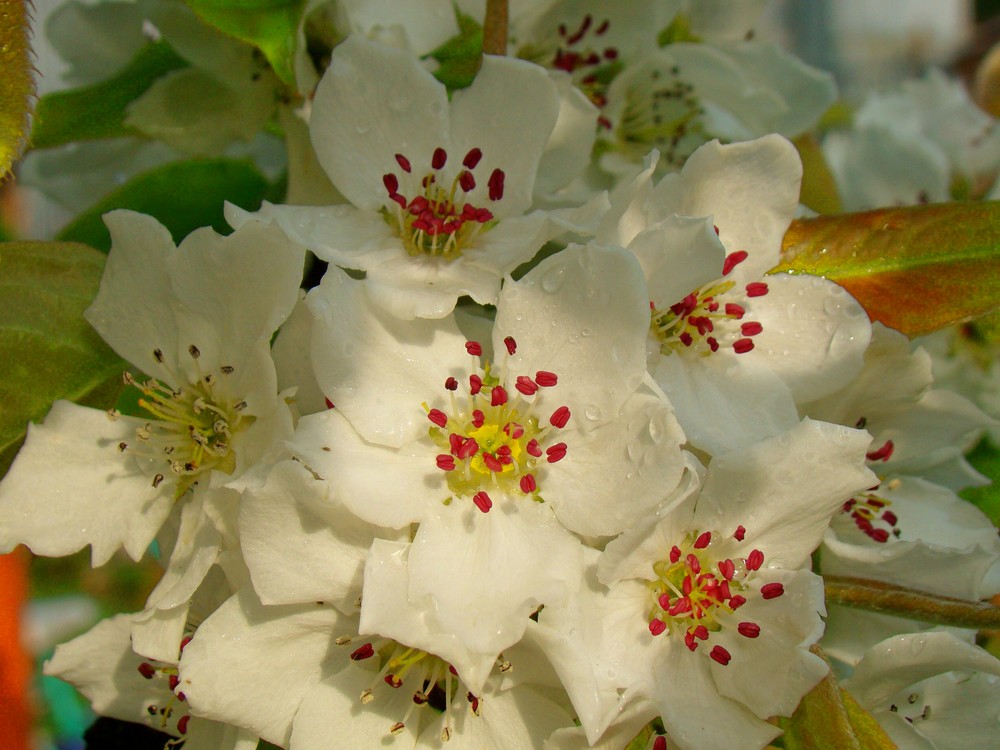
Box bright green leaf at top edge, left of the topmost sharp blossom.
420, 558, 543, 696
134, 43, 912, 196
185, 0, 305, 88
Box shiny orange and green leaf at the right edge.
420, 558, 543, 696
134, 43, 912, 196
774, 201, 1000, 336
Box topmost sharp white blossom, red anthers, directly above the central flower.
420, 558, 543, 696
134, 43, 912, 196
228, 37, 600, 318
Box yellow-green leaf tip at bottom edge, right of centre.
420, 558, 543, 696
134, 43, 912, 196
778, 646, 896, 750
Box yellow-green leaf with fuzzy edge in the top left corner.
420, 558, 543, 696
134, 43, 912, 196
0, 0, 35, 178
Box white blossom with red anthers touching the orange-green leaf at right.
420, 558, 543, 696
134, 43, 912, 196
596, 136, 870, 454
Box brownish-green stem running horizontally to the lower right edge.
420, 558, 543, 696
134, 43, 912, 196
823, 576, 1000, 629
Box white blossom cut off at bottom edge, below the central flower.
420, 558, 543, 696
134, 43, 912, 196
178, 589, 571, 750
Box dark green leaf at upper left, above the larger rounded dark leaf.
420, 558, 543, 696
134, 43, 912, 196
31, 41, 187, 148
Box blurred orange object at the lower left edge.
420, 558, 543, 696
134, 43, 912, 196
0, 549, 31, 750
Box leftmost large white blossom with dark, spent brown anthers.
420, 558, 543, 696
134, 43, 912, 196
0, 211, 304, 659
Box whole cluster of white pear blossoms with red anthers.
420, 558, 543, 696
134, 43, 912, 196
0, 2, 1000, 750
